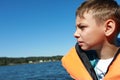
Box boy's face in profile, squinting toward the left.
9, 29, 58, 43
74, 13, 105, 50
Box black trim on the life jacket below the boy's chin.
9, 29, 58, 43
75, 43, 98, 80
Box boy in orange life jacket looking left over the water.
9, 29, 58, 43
62, 0, 120, 80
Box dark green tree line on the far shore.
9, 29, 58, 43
0, 56, 63, 66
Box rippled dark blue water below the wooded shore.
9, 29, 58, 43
0, 62, 72, 80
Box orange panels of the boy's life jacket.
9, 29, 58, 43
61, 43, 120, 80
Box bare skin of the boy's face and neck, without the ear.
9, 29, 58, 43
74, 13, 118, 59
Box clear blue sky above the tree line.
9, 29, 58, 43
0, 0, 119, 57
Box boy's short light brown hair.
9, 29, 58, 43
76, 0, 120, 33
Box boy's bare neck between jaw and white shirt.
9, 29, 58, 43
97, 45, 118, 59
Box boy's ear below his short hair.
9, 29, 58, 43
104, 19, 116, 36
